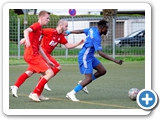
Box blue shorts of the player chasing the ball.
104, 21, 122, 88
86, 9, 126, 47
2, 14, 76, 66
78, 57, 100, 74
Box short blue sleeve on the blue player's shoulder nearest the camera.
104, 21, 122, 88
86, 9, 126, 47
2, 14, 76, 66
93, 33, 102, 51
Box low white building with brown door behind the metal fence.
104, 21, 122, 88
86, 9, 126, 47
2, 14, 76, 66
64, 16, 145, 47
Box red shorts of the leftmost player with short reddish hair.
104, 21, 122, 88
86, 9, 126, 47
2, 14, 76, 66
24, 55, 50, 73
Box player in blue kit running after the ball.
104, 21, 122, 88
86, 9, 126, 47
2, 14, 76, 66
66, 20, 123, 101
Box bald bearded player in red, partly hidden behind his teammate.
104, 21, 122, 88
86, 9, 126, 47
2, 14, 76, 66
12, 19, 84, 100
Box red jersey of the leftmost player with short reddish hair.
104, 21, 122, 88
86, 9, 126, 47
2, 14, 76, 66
24, 22, 42, 55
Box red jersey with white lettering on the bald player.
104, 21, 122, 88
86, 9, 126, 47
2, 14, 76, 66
41, 28, 68, 54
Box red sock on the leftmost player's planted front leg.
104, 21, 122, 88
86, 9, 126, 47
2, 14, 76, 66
32, 77, 48, 96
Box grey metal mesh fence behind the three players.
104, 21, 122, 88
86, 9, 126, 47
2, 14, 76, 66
9, 16, 145, 59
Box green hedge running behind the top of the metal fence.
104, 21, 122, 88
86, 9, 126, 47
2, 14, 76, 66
9, 13, 142, 41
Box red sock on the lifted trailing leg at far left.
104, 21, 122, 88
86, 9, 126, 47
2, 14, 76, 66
14, 73, 29, 88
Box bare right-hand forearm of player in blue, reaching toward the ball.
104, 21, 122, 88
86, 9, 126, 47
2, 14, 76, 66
97, 50, 123, 65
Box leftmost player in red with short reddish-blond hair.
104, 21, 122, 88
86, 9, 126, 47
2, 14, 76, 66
21, 11, 54, 102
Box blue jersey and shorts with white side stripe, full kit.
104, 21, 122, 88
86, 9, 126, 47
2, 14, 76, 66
78, 27, 102, 74
